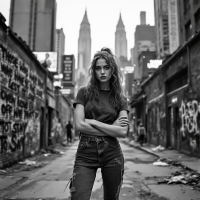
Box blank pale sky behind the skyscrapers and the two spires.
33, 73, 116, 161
0, 0, 155, 63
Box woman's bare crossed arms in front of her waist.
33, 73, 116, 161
74, 104, 129, 138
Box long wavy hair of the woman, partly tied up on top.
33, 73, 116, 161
86, 47, 125, 108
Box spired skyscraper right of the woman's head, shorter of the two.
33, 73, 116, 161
115, 13, 127, 59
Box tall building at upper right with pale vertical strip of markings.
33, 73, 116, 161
154, 0, 180, 59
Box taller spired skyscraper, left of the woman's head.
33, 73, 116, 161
76, 11, 91, 87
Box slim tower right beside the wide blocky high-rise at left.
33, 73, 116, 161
56, 28, 65, 74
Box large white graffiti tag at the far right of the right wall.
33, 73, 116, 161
180, 100, 200, 150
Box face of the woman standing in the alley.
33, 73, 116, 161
94, 58, 112, 83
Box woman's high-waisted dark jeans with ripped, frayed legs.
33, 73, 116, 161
70, 135, 124, 200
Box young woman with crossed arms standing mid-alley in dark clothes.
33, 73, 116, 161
70, 48, 129, 200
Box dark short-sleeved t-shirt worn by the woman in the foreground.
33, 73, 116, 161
73, 87, 128, 124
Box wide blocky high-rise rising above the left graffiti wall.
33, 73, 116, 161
9, 0, 57, 51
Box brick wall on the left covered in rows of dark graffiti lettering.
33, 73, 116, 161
0, 22, 46, 168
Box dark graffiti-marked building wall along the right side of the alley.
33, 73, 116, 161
142, 30, 200, 157
